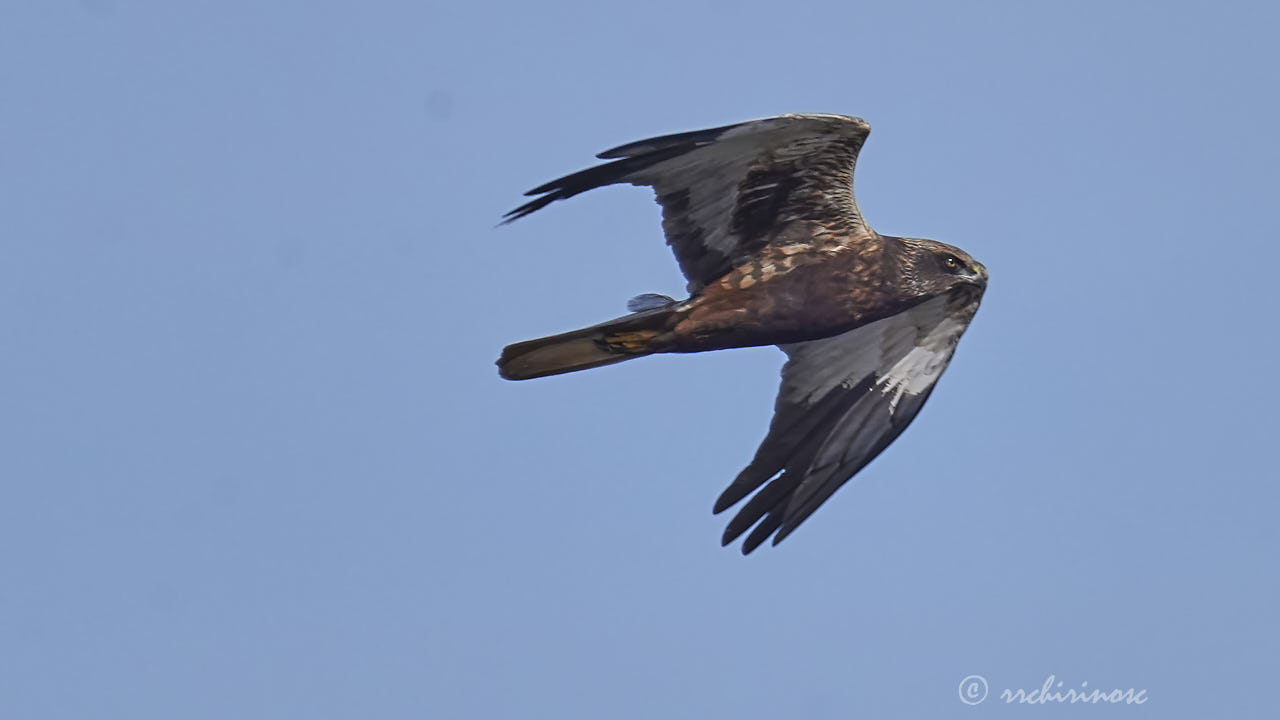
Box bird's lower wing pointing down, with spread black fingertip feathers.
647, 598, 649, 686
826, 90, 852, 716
716, 290, 980, 553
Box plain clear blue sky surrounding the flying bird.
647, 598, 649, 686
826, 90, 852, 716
0, 0, 1280, 719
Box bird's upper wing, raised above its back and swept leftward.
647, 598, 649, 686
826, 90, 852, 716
504, 115, 870, 291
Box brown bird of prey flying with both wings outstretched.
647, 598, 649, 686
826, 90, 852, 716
498, 114, 987, 553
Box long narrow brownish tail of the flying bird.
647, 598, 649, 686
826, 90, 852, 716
498, 307, 675, 380
